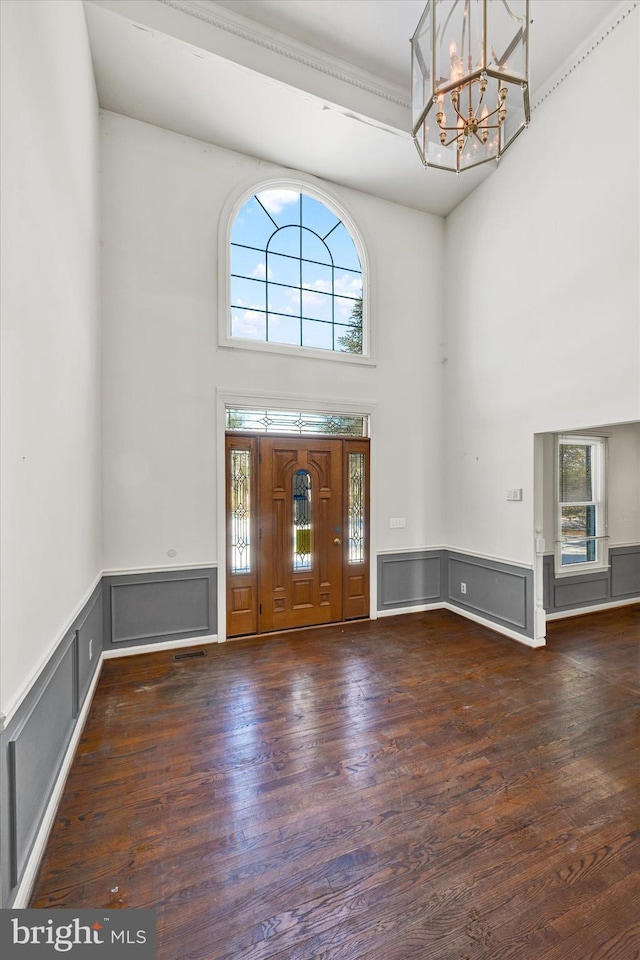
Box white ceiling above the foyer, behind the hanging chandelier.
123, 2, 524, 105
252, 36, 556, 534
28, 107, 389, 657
84, 0, 628, 216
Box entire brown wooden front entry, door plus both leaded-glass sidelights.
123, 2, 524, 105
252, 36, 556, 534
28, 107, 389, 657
226, 434, 369, 637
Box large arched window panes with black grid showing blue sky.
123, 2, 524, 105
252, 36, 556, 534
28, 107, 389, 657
230, 188, 364, 355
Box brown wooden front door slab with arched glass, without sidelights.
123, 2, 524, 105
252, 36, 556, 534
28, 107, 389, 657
258, 437, 342, 632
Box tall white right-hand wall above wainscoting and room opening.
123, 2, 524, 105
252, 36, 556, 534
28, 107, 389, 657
445, 9, 640, 564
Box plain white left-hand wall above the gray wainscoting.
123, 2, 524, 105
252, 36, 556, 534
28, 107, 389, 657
0, 0, 101, 713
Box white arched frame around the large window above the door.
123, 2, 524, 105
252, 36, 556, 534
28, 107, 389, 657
218, 177, 375, 365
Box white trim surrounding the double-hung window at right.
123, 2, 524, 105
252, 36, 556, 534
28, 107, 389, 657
554, 433, 609, 579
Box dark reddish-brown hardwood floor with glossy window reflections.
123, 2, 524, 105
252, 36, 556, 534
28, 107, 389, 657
31, 605, 640, 960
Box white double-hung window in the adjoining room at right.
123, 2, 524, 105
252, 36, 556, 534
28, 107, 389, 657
556, 435, 607, 575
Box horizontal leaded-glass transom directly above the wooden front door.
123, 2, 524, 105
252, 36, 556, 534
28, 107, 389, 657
227, 408, 368, 437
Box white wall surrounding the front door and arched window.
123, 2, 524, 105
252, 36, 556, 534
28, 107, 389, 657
102, 113, 443, 570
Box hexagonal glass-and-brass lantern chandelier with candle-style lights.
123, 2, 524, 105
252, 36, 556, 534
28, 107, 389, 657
411, 0, 529, 173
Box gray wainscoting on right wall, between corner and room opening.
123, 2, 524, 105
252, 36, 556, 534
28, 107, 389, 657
448, 553, 533, 636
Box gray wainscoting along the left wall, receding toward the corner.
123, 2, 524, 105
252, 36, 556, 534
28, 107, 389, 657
0, 584, 102, 907
